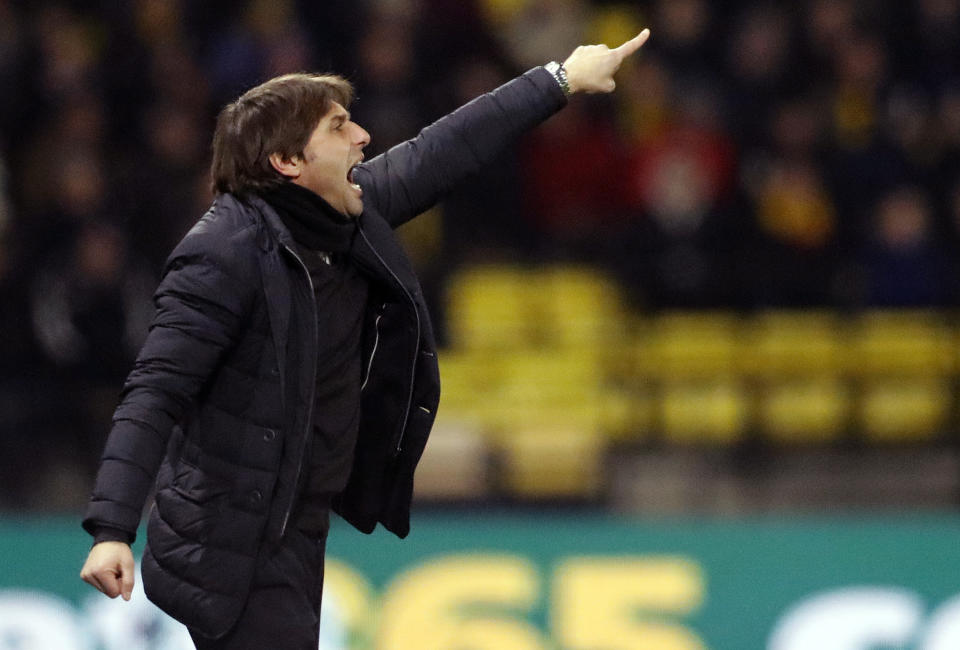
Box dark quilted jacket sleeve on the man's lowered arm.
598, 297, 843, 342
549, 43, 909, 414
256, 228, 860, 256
83, 220, 256, 535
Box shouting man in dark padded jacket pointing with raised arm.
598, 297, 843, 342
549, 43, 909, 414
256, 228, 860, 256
81, 30, 649, 650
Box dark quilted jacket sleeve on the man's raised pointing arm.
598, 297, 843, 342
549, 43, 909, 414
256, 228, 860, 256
355, 67, 567, 228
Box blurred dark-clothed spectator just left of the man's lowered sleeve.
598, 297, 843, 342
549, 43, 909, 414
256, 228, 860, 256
29, 221, 154, 480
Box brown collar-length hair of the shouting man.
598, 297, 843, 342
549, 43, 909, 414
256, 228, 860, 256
210, 73, 353, 194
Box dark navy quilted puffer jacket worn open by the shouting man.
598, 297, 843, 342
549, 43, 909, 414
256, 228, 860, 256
83, 68, 566, 637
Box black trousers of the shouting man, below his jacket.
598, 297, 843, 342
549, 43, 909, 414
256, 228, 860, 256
190, 528, 327, 650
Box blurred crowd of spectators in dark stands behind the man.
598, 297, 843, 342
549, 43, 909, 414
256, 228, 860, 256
0, 0, 960, 506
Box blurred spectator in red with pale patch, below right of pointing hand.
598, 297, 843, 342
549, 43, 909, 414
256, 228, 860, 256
606, 79, 736, 307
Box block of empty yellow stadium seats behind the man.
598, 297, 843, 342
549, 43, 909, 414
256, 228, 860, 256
432, 266, 960, 497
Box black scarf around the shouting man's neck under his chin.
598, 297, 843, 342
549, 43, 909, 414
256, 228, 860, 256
262, 181, 357, 253
